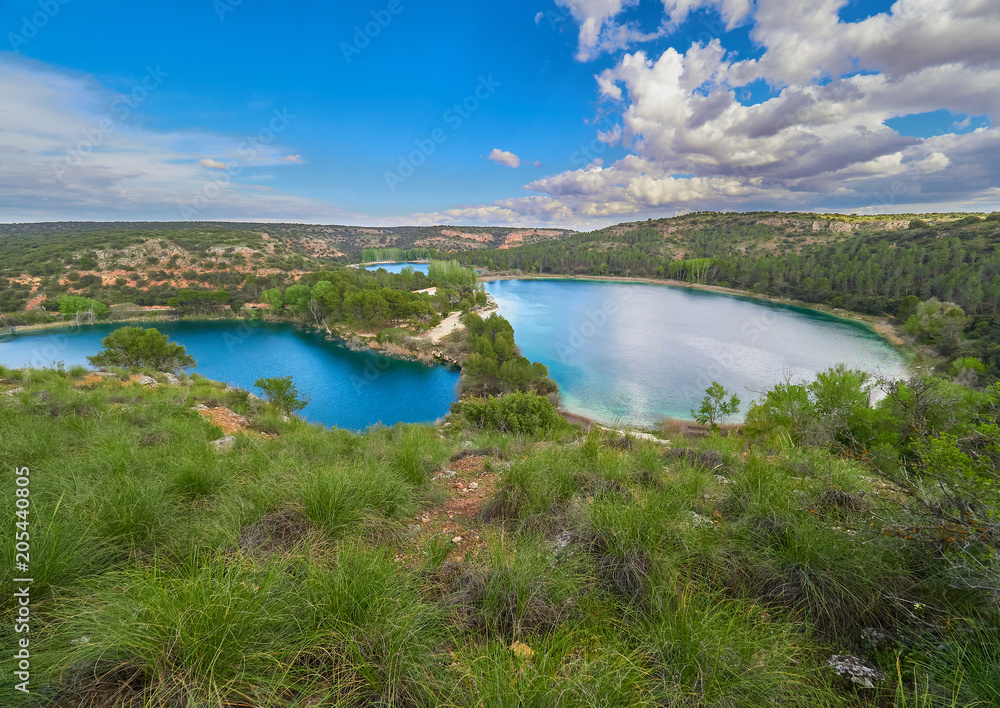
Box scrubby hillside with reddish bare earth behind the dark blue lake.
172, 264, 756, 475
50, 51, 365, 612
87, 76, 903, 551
0, 222, 571, 324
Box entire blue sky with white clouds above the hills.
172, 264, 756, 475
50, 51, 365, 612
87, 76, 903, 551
0, 0, 1000, 230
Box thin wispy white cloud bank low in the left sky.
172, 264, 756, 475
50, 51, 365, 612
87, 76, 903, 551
0, 54, 366, 223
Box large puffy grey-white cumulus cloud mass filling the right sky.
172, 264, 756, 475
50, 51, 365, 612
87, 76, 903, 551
438, 0, 1000, 225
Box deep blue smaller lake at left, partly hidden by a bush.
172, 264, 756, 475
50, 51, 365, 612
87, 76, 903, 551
0, 321, 458, 430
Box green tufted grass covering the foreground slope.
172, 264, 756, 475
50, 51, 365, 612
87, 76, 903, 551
0, 370, 1000, 708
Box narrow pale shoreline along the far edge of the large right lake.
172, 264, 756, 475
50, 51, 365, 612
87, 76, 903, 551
479, 273, 921, 360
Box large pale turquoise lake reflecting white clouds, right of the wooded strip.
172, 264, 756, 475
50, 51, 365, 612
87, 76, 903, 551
486, 280, 905, 425
